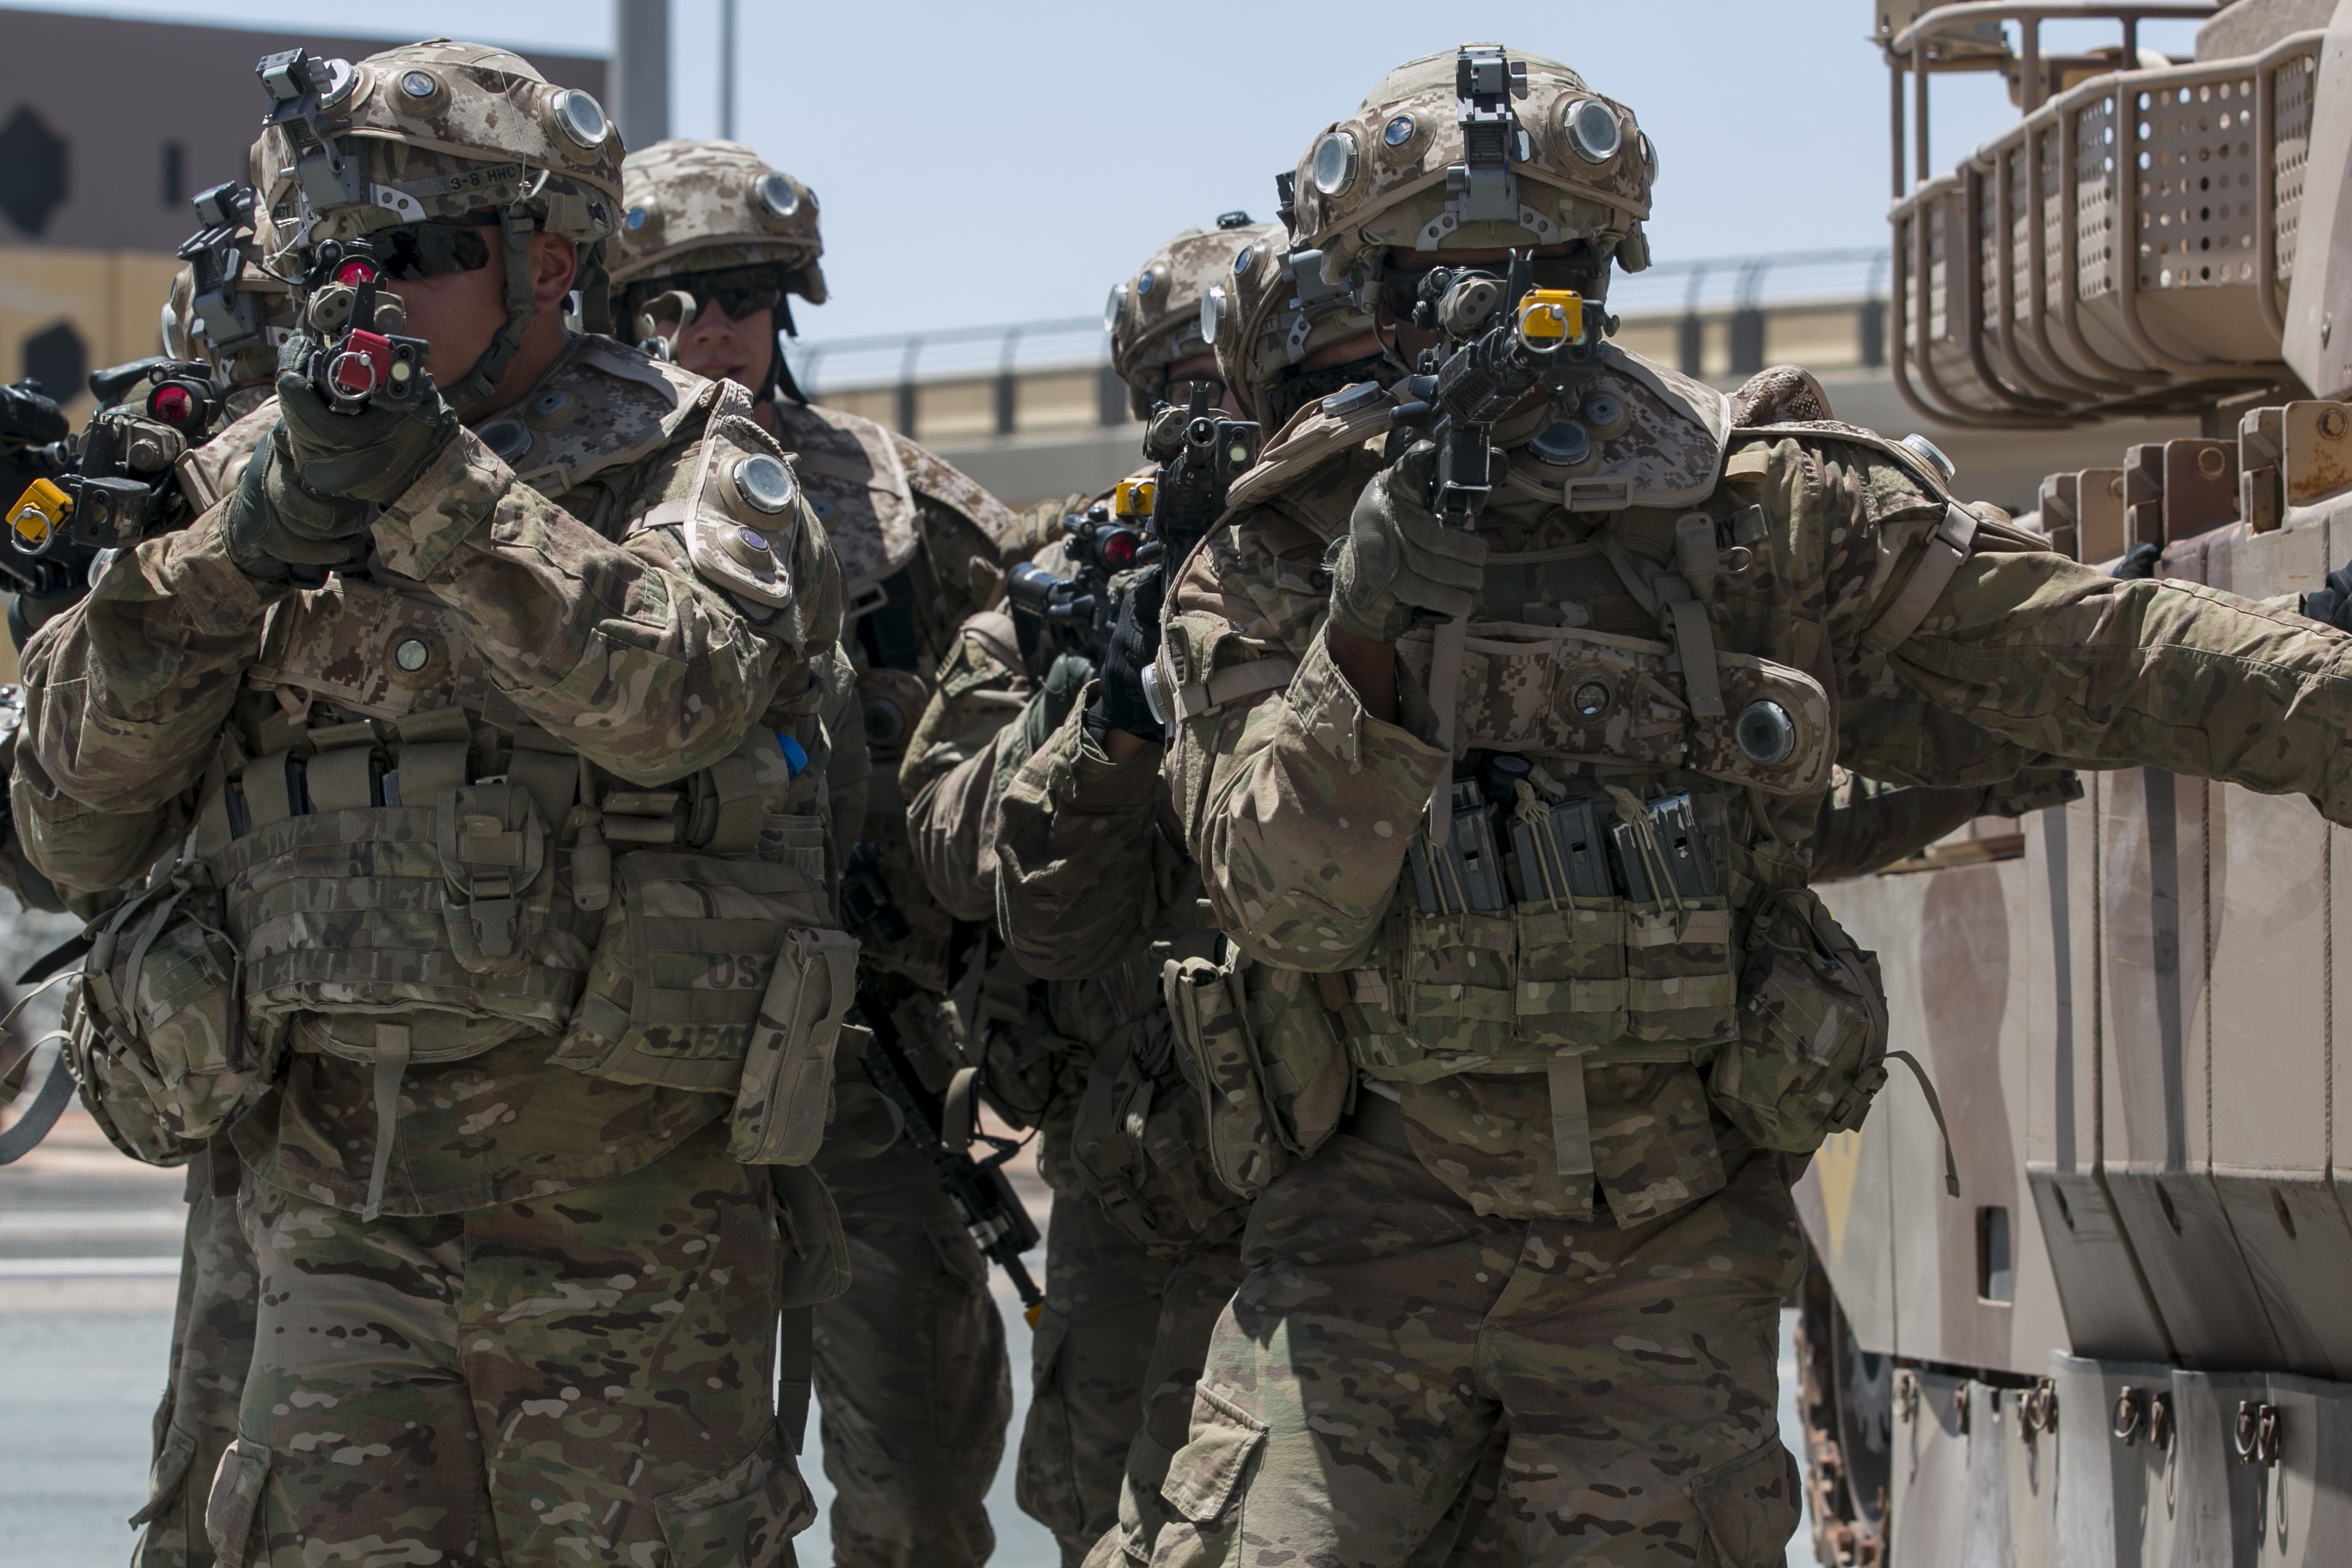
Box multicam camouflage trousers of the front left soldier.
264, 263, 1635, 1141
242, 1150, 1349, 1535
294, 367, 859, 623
205, 1124, 814, 1568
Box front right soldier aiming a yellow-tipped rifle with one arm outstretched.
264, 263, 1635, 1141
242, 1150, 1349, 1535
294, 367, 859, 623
1155, 45, 2352, 1565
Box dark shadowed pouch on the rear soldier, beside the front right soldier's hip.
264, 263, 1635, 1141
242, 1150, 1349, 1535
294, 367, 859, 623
1070, 1008, 1249, 1258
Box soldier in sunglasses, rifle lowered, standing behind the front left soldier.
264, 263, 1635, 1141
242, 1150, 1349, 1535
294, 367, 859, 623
614, 141, 1019, 1568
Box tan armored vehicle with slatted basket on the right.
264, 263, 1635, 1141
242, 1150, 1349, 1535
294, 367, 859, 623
1799, 0, 2352, 1568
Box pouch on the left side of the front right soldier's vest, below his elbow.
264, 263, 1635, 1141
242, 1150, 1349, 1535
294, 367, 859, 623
1162, 943, 1355, 1197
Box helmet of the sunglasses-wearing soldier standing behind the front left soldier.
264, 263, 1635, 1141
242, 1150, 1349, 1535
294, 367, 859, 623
611, 138, 825, 402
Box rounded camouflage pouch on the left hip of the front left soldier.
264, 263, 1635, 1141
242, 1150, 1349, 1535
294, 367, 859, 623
66, 867, 282, 1166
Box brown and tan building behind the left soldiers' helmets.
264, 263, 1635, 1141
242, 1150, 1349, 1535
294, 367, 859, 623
0, 9, 604, 416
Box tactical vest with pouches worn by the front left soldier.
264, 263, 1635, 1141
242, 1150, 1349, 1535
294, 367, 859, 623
70, 343, 856, 1213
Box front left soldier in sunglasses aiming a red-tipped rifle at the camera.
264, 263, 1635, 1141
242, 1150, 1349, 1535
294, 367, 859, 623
12, 40, 854, 1565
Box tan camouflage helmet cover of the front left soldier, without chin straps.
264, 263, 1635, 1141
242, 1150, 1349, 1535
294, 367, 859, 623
252, 38, 621, 270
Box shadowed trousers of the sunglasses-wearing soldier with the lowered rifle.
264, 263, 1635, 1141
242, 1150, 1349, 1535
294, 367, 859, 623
816, 1138, 1014, 1568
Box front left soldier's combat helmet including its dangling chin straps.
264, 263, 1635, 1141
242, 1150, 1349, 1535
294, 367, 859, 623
252, 38, 621, 409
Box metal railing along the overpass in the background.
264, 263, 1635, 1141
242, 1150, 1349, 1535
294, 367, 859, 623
783, 247, 1889, 438
